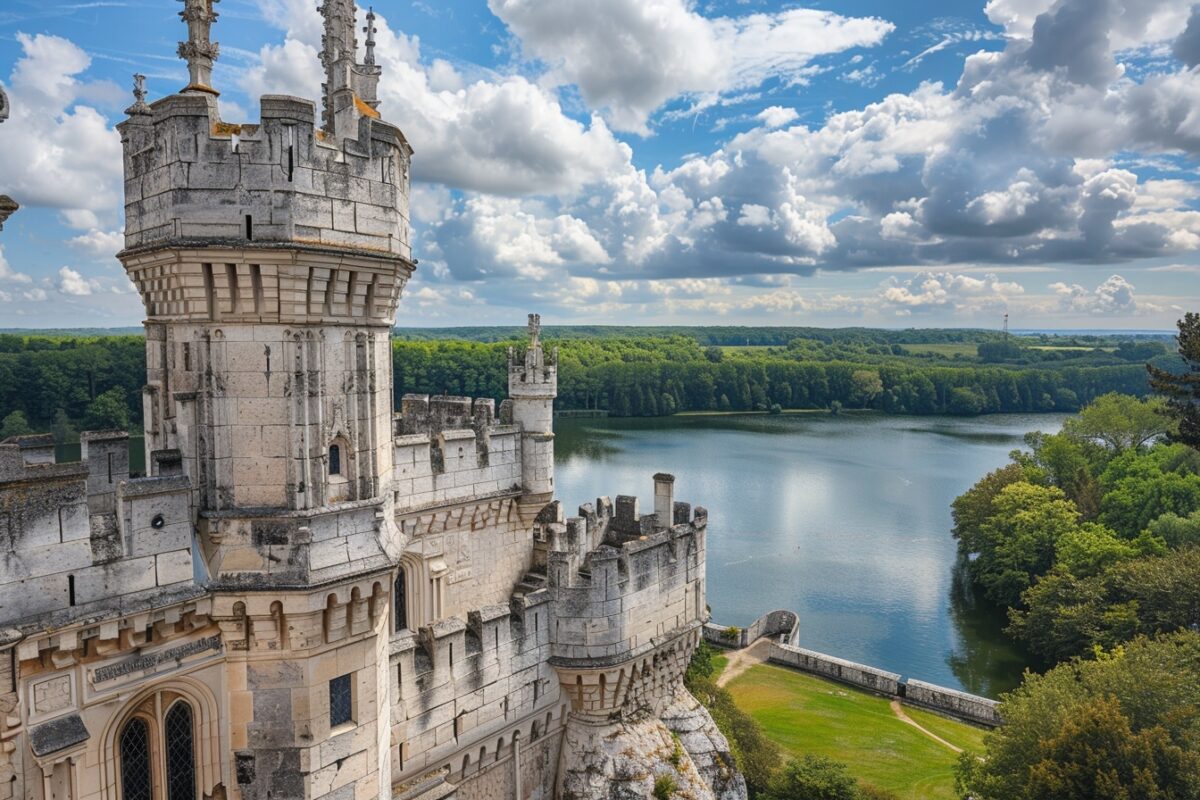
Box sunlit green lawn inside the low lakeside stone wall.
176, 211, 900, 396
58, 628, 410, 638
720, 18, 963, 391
726, 664, 984, 800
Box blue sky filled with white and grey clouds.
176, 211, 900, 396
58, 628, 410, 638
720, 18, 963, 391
0, 0, 1200, 330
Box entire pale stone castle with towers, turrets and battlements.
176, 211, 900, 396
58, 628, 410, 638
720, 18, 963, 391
0, 0, 745, 800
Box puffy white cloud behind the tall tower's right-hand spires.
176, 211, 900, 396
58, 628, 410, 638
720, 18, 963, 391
241, 0, 631, 194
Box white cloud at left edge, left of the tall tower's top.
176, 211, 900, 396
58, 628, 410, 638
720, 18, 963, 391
0, 34, 121, 228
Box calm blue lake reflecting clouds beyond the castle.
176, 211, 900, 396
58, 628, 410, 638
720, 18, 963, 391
554, 414, 1062, 697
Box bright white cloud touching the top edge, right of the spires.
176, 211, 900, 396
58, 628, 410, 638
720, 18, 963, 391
488, 0, 894, 133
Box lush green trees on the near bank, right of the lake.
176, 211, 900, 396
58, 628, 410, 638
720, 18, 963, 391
954, 314, 1200, 800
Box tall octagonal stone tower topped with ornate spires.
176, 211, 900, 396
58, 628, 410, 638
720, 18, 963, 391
119, 0, 414, 800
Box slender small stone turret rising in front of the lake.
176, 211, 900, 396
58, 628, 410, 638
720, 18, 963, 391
509, 314, 558, 504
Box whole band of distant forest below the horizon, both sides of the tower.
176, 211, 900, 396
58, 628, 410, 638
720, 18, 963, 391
0, 326, 1177, 440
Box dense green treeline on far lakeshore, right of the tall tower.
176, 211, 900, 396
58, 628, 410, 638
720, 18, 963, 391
392, 337, 1147, 416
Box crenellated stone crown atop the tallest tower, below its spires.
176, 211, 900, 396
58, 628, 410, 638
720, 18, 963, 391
119, 92, 413, 260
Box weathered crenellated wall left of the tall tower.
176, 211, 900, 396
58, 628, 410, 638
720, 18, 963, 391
0, 431, 203, 627
